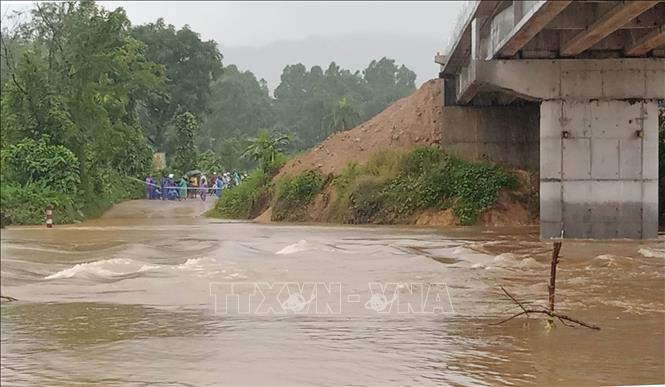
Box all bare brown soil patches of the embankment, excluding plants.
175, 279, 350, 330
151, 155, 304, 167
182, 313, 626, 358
256, 79, 538, 226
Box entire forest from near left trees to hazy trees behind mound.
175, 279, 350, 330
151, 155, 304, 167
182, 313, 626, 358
0, 1, 416, 223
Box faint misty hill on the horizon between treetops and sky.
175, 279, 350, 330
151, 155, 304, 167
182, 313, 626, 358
220, 34, 444, 91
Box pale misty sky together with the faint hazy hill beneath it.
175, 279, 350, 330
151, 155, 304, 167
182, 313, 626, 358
2, 1, 463, 88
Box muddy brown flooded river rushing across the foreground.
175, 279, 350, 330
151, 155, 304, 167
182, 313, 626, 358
0, 201, 665, 386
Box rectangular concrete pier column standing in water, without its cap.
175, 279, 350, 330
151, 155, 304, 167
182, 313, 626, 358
540, 99, 658, 239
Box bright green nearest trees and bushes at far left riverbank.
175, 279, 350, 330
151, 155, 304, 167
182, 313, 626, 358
0, 1, 160, 223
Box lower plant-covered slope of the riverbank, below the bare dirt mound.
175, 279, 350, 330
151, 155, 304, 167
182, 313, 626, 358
209, 148, 538, 226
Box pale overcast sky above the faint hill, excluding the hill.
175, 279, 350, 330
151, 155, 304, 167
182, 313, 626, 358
99, 1, 461, 46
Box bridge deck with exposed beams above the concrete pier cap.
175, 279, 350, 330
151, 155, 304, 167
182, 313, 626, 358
436, 0, 665, 76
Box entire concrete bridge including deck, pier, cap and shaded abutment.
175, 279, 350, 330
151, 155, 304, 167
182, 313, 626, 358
435, 0, 665, 239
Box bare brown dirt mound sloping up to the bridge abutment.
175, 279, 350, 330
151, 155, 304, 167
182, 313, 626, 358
276, 79, 442, 179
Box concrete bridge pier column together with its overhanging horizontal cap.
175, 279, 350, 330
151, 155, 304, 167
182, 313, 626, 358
446, 58, 665, 239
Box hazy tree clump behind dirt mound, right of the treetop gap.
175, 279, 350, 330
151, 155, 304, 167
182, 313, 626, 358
274, 58, 416, 149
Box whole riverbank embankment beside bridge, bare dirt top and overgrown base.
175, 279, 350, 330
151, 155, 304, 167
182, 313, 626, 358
210, 80, 539, 226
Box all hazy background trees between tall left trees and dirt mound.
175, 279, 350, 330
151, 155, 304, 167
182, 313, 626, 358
197, 58, 416, 162
